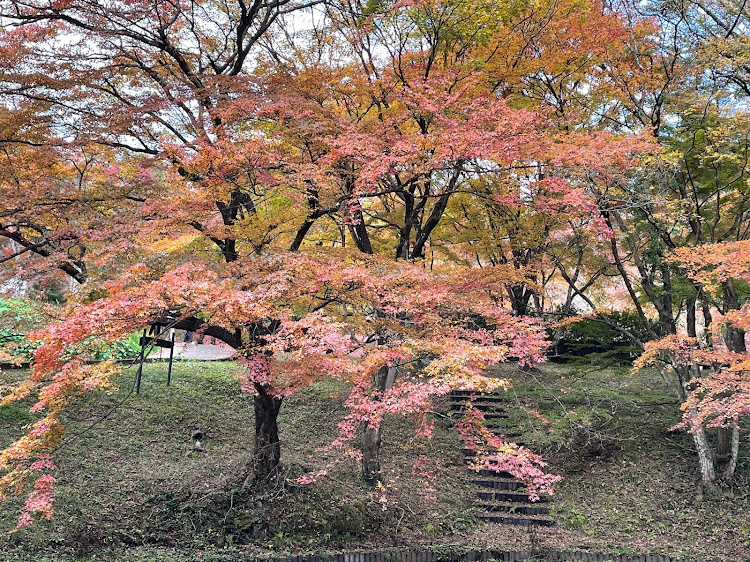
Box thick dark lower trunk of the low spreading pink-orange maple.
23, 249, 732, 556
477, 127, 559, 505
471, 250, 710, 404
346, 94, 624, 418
247, 384, 283, 479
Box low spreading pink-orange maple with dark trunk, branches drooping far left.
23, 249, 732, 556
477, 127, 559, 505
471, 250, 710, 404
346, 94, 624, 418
0, 247, 554, 524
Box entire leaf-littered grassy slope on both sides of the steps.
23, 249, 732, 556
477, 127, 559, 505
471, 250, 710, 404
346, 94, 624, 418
0, 363, 750, 560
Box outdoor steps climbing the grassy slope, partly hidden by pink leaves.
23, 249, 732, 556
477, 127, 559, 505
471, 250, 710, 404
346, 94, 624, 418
449, 390, 553, 526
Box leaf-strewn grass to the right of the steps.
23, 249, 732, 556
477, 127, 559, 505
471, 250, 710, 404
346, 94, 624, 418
470, 360, 750, 560
